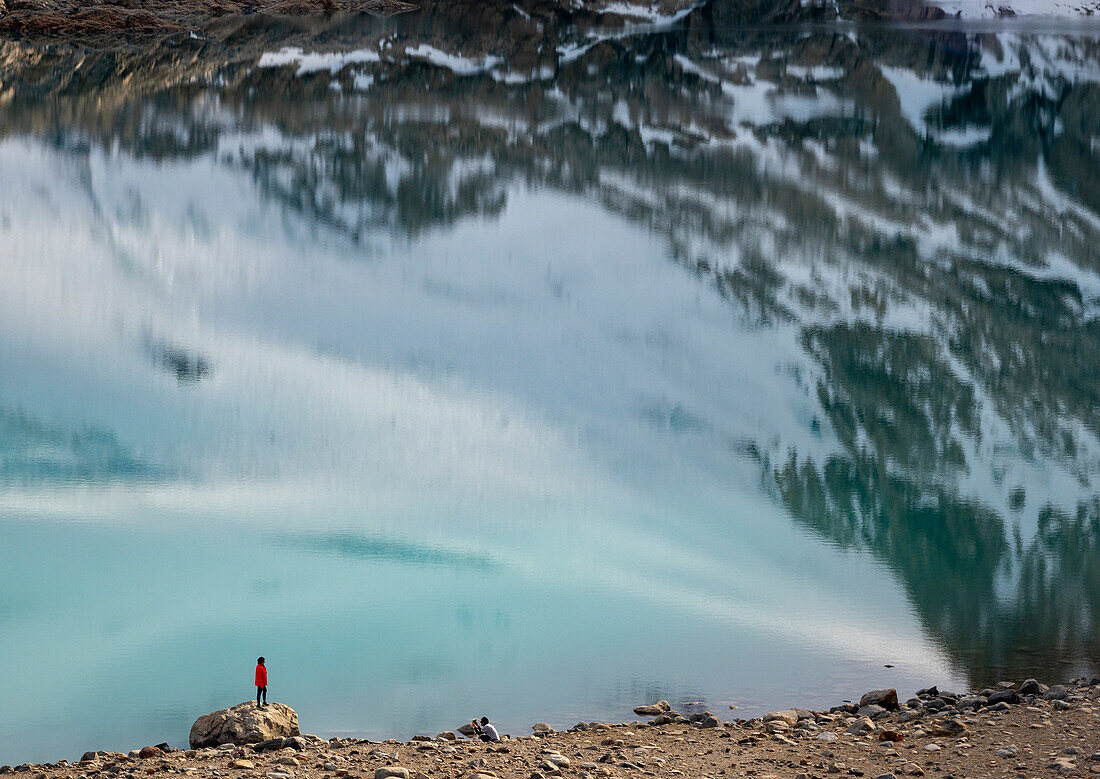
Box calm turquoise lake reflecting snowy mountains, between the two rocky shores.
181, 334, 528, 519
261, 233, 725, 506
0, 7, 1100, 762
